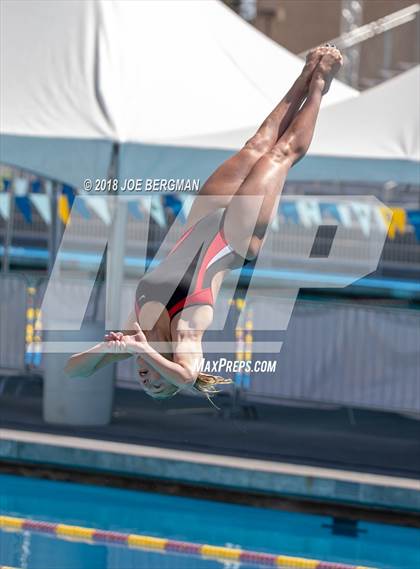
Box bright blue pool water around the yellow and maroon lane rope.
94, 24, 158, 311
0, 475, 420, 569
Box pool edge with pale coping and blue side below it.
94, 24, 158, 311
0, 428, 420, 512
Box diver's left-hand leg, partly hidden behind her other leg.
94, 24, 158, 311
188, 46, 329, 225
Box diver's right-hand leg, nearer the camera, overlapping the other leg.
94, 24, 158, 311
224, 48, 342, 258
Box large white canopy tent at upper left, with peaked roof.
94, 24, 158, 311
0, 0, 357, 187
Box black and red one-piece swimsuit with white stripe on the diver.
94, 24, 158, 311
136, 210, 247, 319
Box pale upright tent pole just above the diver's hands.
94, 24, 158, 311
106, 143, 128, 330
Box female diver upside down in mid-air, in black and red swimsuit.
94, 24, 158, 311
65, 44, 342, 399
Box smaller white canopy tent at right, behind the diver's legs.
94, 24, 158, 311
188, 66, 420, 184
